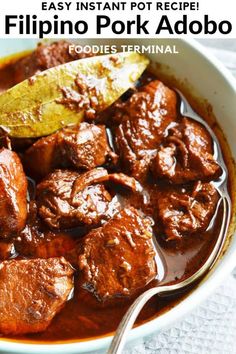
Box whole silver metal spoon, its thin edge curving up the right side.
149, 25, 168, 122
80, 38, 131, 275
107, 90, 231, 354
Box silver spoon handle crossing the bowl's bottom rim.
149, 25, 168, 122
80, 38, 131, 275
107, 286, 169, 354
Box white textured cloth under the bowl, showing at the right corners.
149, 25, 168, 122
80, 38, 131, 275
121, 39, 236, 354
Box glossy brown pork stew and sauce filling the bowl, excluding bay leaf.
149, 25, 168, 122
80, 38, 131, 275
0, 41, 230, 341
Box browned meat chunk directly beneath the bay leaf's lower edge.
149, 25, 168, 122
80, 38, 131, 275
24, 122, 116, 179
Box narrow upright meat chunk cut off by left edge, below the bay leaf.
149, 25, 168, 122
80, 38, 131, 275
0, 148, 27, 238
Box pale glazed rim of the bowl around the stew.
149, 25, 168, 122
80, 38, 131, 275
0, 38, 236, 354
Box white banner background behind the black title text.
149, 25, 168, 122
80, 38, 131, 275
0, 0, 236, 38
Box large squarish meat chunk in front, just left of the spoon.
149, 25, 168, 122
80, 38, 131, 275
78, 208, 157, 301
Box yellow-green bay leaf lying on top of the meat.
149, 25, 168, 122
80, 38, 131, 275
0, 52, 149, 138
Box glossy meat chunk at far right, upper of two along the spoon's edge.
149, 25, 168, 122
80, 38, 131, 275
153, 118, 220, 184
